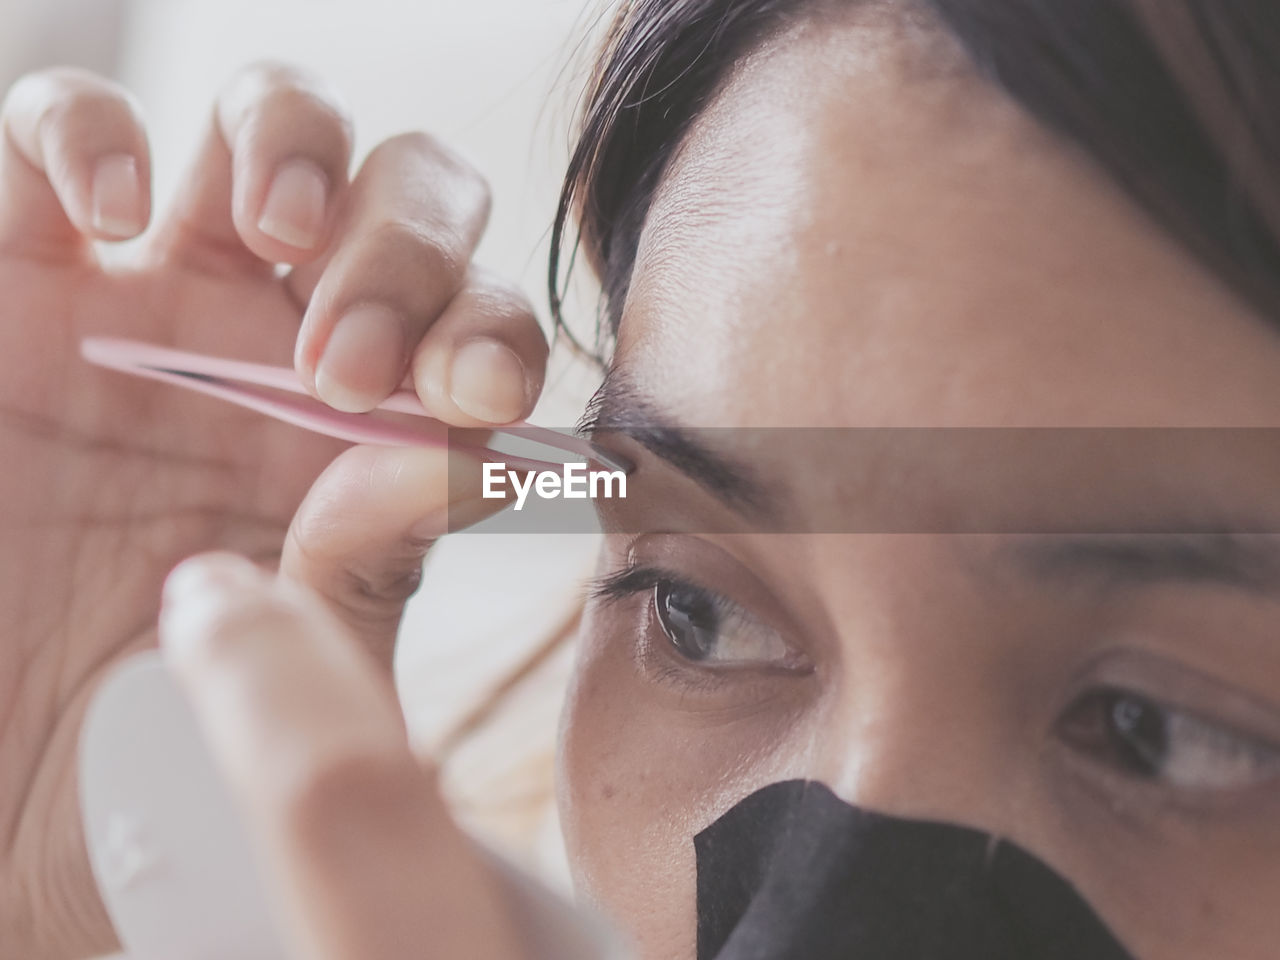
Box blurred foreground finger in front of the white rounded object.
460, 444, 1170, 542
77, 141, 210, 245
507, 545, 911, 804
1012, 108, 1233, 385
160, 554, 525, 960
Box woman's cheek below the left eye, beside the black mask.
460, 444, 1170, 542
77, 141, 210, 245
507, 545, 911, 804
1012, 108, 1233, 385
557, 614, 819, 957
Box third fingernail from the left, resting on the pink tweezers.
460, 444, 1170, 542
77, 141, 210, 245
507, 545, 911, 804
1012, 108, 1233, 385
316, 303, 406, 413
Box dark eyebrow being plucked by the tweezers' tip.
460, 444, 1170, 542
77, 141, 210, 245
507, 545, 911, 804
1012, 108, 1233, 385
576, 366, 778, 517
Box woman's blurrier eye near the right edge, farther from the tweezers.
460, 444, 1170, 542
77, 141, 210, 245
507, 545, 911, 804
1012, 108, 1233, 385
1060, 690, 1280, 792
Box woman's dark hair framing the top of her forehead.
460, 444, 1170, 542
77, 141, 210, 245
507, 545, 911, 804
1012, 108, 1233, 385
548, 0, 1280, 358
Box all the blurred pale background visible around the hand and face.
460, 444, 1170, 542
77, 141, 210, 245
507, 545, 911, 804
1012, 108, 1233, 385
0, 0, 614, 885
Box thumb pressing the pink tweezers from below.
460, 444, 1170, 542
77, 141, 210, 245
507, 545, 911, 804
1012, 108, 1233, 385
280, 447, 504, 669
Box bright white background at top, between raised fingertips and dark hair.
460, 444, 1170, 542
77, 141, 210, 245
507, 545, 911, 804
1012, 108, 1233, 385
120, 0, 590, 317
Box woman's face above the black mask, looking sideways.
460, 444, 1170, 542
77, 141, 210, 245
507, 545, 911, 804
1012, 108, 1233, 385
561, 9, 1280, 960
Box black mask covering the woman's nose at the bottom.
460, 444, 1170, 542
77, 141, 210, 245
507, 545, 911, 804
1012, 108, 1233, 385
694, 781, 1133, 960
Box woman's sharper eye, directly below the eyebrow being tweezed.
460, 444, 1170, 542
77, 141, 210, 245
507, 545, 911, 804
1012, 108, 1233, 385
653, 580, 794, 667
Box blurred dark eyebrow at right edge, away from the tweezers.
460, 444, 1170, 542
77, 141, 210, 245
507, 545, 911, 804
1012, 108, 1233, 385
1014, 531, 1280, 595
